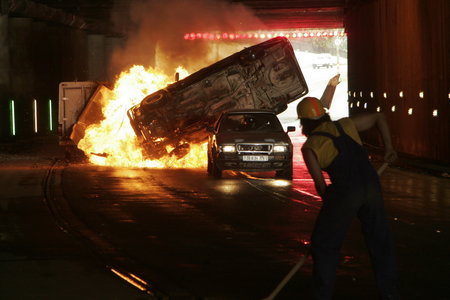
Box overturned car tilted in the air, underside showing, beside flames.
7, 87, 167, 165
128, 37, 308, 159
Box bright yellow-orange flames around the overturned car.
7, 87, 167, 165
78, 66, 207, 168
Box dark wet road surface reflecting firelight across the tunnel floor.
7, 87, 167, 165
0, 137, 450, 299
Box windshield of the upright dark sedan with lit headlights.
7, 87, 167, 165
219, 113, 283, 132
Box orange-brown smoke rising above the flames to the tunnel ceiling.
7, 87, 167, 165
112, 0, 264, 74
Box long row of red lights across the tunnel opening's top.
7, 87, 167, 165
184, 30, 347, 41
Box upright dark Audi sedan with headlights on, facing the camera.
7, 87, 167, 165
208, 110, 295, 179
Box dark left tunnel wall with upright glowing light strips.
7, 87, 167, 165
0, 14, 121, 142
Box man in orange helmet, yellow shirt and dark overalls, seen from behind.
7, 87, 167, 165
297, 97, 398, 299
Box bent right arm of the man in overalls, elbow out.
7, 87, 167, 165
350, 113, 397, 163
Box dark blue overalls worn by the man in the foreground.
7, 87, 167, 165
311, 122, 398, 299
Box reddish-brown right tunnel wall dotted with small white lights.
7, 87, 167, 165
345, 0, 450, 164
